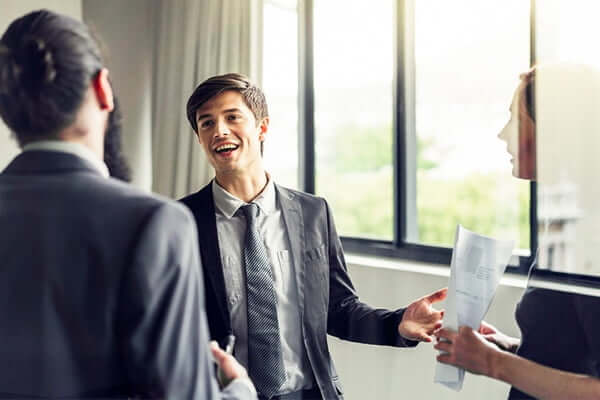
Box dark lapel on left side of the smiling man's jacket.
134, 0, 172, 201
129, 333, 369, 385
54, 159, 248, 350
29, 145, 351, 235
194, 184, 231, 331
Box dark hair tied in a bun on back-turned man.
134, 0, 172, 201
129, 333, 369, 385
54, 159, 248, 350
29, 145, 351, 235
0, 10, 103, 146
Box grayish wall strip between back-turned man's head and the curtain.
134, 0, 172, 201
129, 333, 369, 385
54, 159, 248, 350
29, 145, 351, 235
82, 0, 157, 190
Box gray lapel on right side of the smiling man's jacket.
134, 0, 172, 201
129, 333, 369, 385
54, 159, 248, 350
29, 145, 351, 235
275, 185, 305, 320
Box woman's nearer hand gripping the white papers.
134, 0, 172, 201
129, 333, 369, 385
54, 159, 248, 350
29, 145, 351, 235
433, 326, 506, 377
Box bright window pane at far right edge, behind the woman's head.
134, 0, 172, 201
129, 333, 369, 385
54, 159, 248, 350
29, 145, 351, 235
535, 0, 600, 275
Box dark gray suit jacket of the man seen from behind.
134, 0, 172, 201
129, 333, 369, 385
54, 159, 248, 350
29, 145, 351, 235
0, 151, 251, 399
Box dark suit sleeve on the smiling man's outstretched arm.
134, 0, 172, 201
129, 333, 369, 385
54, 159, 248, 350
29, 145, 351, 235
323, 200, 418, 347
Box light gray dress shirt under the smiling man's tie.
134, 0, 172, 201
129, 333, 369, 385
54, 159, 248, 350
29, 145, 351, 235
212, 178, 314, 393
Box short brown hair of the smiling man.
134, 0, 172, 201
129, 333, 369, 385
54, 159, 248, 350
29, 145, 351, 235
186, 73, 269, 133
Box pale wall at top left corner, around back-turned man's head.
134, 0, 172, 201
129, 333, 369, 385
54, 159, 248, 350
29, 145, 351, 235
0, 0, 81, 170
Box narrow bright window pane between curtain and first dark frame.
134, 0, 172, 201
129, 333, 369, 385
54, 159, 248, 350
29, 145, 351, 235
262, 0, 298, 189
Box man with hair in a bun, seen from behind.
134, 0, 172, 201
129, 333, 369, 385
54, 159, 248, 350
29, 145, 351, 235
0, 11, 256, 399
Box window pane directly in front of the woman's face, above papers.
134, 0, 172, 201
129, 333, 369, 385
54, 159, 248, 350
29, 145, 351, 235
414, 0, 530, 253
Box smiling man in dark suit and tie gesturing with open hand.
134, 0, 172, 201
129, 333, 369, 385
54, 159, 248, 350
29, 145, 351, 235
181, 74, 446, 400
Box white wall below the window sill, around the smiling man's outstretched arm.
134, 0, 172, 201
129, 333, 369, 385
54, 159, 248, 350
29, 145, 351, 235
329, 265, 523, 400
